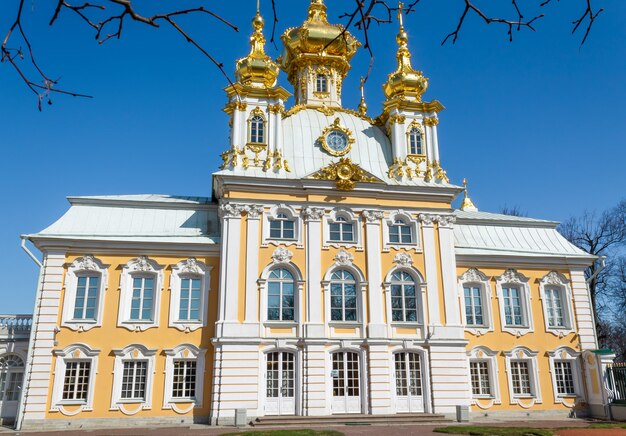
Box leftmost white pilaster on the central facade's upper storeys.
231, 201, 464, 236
216, 203, 246, 337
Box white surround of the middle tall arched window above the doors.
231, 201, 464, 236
322, 250, 367, 331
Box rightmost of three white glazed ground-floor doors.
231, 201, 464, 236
394, 353, 424, 413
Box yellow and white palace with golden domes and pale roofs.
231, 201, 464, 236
12, 0, 605, 428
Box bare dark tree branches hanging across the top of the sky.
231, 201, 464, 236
0, 0, 604, 110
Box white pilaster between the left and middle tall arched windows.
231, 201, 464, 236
302, 207, 325, 338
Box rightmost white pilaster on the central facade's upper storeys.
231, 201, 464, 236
437, 215, 463, 330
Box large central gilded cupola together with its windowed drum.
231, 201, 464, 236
279, 0, 361, 106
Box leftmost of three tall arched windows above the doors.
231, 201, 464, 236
267, 268, 295, 321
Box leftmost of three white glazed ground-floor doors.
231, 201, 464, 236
265, 351, 296, 415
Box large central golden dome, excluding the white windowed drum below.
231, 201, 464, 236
280, 0, 361, 81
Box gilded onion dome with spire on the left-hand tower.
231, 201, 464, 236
235, 10, 279, 88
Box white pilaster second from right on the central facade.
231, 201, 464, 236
419, 214, 441, 327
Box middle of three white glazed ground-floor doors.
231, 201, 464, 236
332, 351, 361, 413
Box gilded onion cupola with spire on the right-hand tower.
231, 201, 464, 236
383, 3, 428, 102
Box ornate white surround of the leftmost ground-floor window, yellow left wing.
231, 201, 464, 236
50, 344, 100, 416
